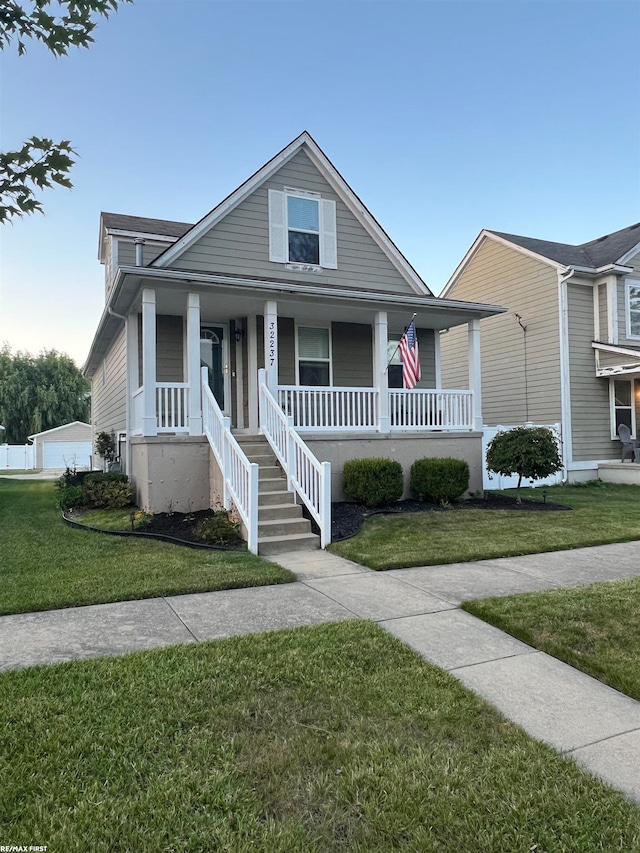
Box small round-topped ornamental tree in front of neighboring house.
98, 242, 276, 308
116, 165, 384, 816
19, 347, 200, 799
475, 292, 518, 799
487, 427, 562, 503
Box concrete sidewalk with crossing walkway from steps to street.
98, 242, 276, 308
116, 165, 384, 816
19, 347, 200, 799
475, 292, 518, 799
0, 542, 640, 803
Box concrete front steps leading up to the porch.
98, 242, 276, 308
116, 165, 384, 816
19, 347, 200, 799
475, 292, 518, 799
235, 433, 320, 556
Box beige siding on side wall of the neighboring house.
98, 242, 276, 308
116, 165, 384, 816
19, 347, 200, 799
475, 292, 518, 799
440, 239, 560, 425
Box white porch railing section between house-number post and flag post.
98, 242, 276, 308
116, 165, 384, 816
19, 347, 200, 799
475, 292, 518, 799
278, 385, 378, 430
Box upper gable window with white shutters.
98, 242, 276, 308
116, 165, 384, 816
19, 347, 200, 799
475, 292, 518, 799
269, 187, 338, 272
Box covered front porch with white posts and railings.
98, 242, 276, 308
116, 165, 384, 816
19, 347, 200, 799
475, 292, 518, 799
127, 288, 482, 437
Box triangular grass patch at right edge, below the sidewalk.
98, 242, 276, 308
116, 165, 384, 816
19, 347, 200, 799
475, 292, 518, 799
463, 578, 640, 701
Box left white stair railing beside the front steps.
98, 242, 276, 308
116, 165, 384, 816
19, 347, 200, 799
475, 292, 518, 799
201, 367, 259, 554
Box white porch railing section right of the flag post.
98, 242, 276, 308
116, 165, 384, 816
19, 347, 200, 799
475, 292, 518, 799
389, 388, 473, 430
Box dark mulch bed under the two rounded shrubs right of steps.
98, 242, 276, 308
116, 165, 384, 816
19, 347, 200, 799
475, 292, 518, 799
331, 494, 571, 542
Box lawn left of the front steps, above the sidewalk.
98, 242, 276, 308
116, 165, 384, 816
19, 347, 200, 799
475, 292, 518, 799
0, 477, 295, 615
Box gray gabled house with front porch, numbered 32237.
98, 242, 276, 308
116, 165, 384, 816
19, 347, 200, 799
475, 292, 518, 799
85, 127, 503, 553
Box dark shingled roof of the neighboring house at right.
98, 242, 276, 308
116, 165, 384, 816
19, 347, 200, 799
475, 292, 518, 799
488, 222, 640, 269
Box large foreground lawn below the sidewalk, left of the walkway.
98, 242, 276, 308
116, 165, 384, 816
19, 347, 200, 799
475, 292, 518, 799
5, 621, 640, 853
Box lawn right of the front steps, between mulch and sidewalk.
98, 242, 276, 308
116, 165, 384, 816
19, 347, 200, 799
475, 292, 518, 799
331, 483, 640, 569
